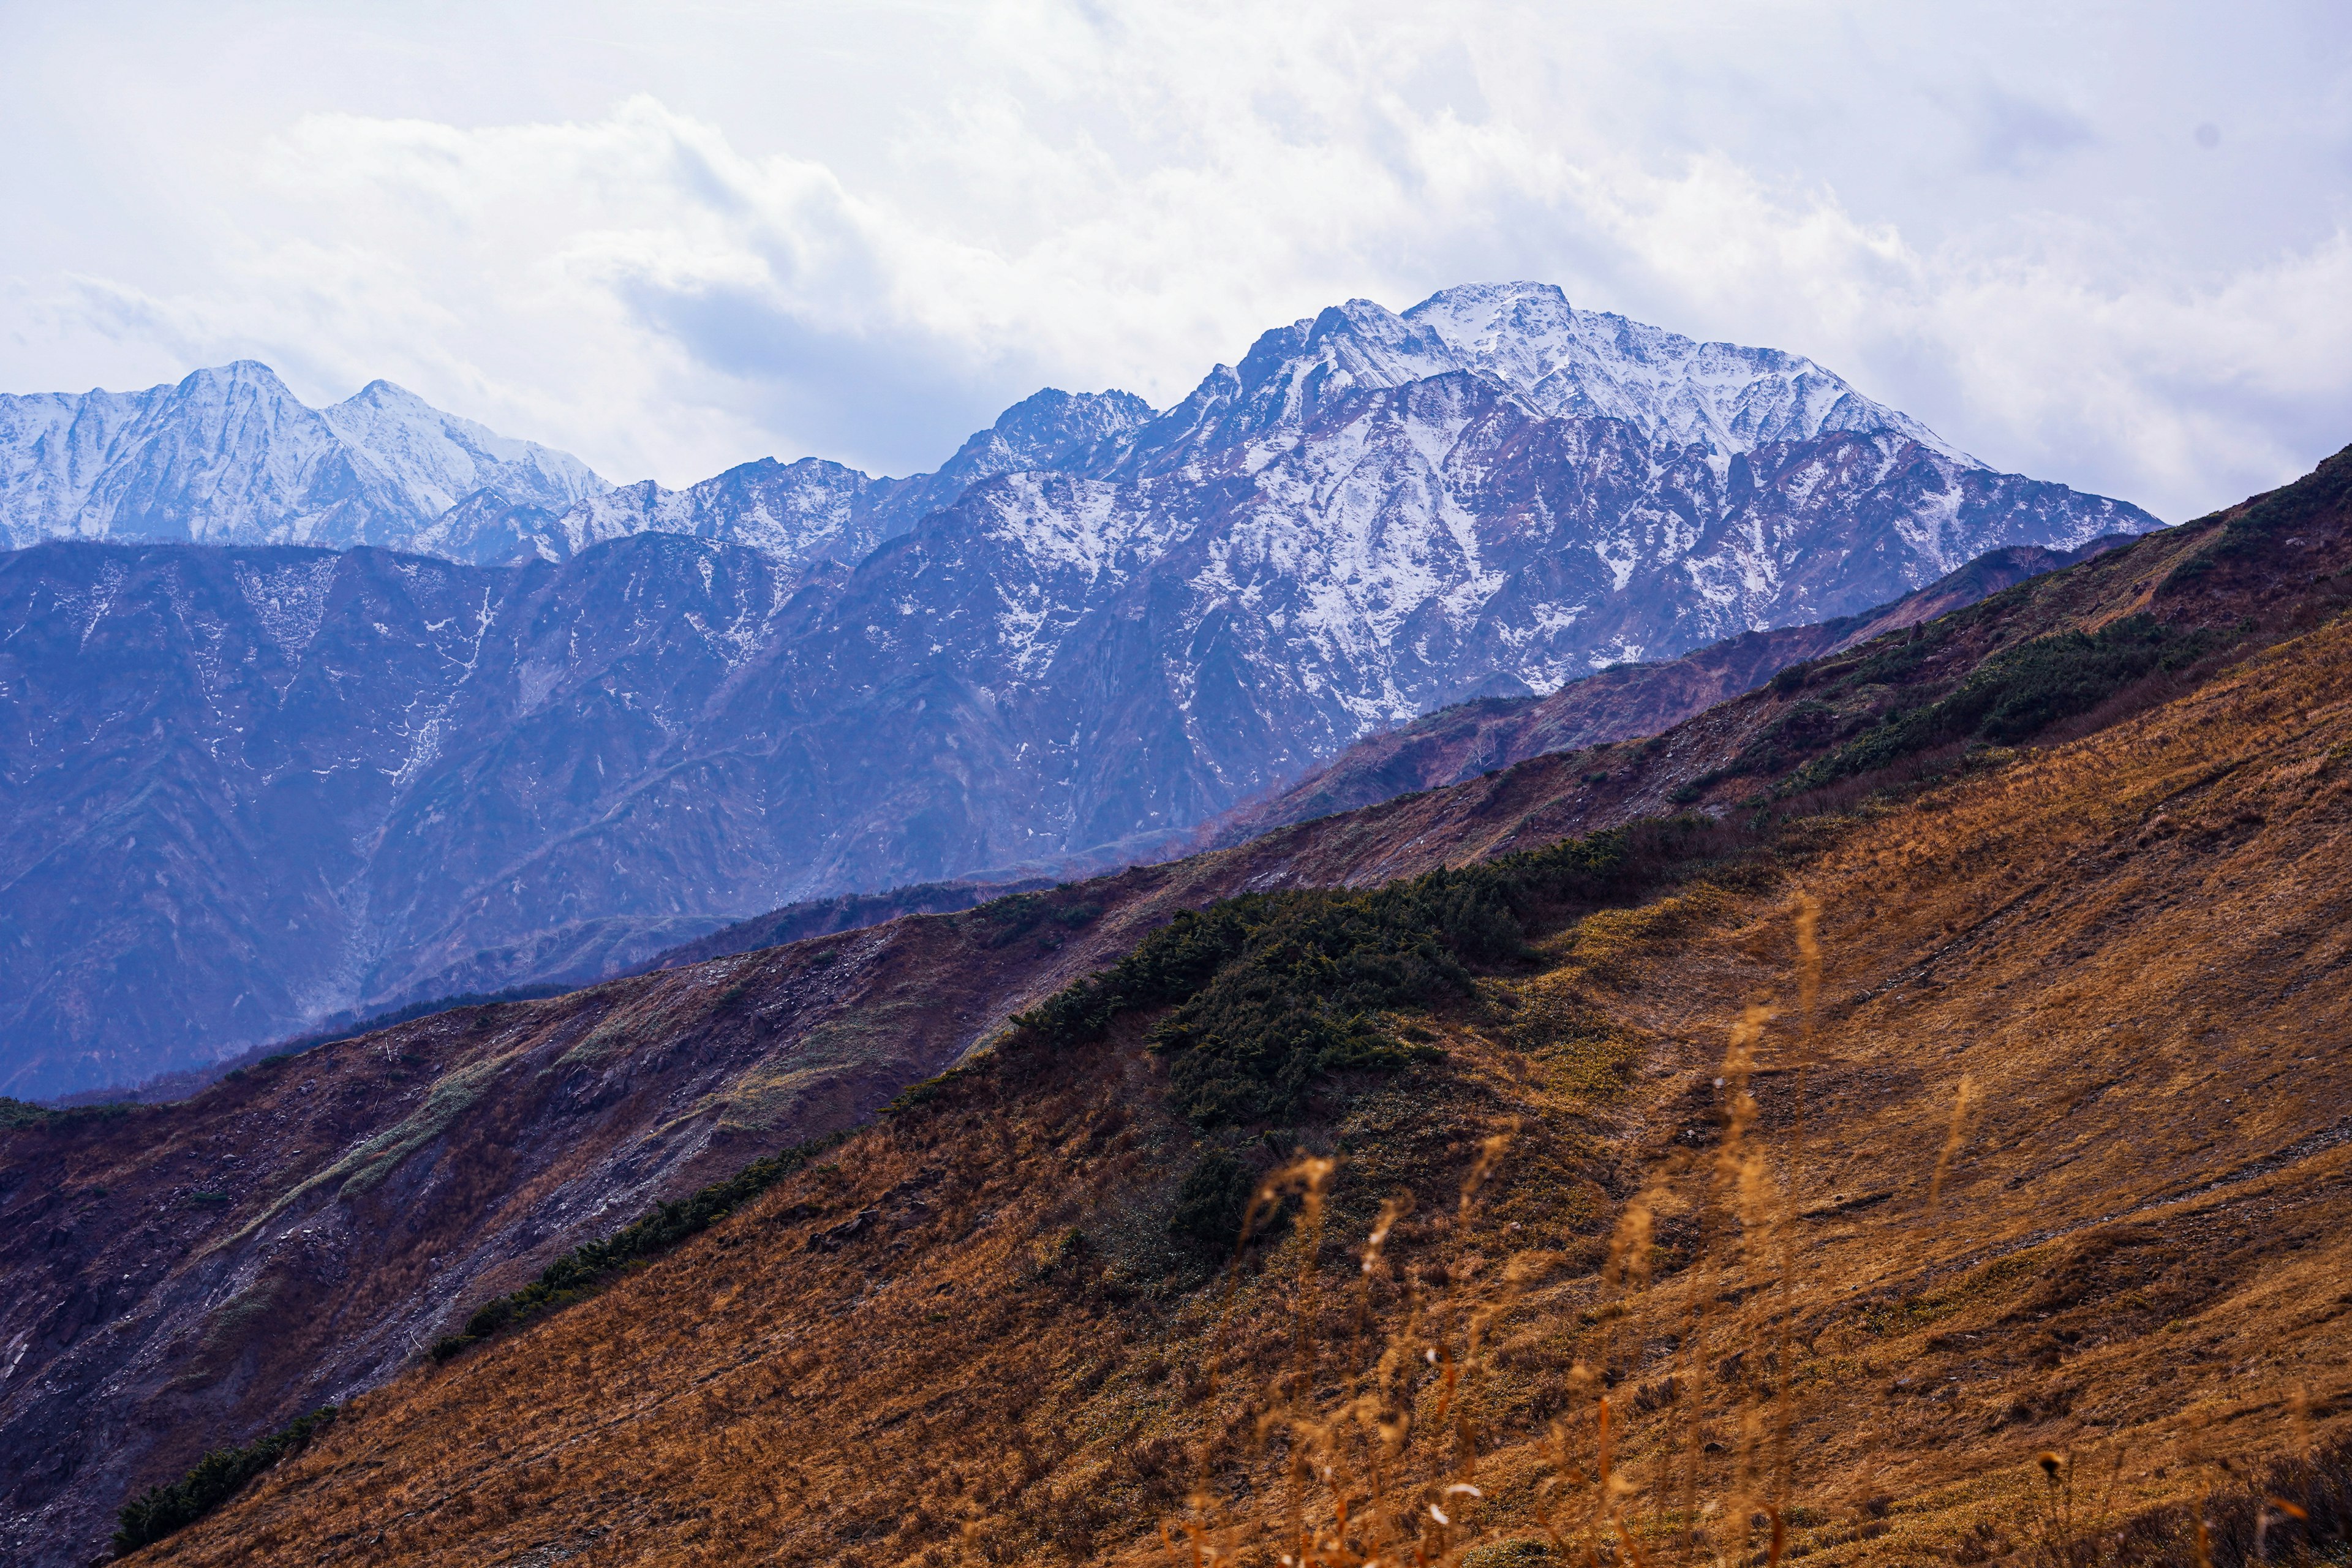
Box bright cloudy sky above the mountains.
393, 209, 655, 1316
0, 0, 2352, 519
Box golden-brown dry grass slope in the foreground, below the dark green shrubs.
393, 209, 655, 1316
137, 531, 2352, 1568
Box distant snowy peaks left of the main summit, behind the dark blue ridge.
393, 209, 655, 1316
0, 360, 1153, 567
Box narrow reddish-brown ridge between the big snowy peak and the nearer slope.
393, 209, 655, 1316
1232, 536, 2131, 846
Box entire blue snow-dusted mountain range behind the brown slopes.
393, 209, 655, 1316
0, 284, 2154, 1093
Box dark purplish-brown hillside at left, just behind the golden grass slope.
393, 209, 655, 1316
0, 724, 1740, 1563
